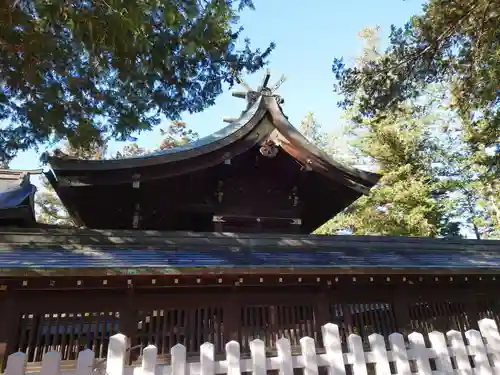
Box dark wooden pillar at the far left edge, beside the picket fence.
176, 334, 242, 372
0, 292, 20, 372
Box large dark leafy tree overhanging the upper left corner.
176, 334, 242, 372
0, 0, 274, 162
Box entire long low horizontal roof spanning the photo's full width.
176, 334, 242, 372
0, 228, 500, 276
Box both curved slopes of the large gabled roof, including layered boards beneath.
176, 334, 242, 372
49, 90, 380, 194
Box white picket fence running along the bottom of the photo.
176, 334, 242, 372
5, 319, 500, 375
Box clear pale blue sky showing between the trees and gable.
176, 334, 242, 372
11, 0, 423, 169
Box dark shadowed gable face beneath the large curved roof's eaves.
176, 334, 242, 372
49, 142, 361, 233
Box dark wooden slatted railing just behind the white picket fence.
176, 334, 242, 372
5, 295, 500, 363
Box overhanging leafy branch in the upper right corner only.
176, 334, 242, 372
333, 0, 500, 137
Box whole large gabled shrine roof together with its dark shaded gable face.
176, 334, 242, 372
47, 90, 380, 233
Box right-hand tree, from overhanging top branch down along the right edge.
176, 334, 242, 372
333, 7, 500, 235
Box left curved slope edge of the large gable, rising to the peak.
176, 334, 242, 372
49, 97, 266, 171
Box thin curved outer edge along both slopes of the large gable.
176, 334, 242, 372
49, 95, 381, 194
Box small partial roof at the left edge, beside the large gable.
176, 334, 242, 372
0, 169, 42, 225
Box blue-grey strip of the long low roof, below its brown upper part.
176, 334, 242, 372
0, 248, 500, 269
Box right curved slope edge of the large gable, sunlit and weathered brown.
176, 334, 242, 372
264, 97, 382, 188
